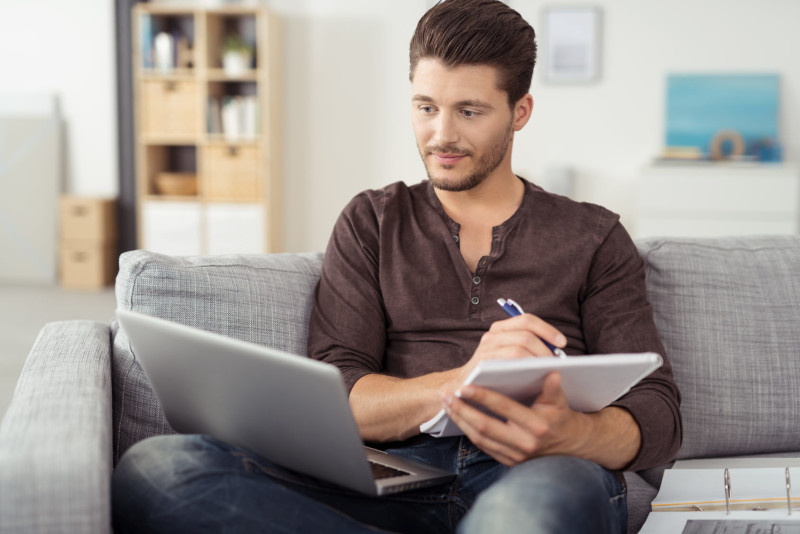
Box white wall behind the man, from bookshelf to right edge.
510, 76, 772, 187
267, 0, 800, 251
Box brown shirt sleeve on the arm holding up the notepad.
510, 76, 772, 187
581, 216, 683, 471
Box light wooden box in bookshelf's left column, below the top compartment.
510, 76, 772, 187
142, 80, 199, 137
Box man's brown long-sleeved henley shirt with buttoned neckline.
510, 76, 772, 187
308, 180, 682, 470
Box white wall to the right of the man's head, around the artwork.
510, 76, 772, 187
512, 0, 800, 233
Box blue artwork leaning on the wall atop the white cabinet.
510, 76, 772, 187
666, 74, 780, 161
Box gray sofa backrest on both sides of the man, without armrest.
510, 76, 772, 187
112, 236, 800, 468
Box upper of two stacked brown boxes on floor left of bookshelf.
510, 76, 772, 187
59, 195, 117, 243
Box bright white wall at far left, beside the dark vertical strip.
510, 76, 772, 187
0, 0, 119, 196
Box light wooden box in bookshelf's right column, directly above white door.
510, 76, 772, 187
203, 145, 262, 202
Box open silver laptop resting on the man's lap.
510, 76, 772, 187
117, 309, 455, 495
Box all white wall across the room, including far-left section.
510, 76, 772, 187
0, 0, 800, 251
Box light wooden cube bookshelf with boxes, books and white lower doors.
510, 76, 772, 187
132, 4, 282, 255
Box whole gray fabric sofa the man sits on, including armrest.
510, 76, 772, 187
0, 236, 800, 534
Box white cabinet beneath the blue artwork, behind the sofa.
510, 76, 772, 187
633, 164, 800, 238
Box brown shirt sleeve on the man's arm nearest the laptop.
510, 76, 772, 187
308, 191, 387, 392
